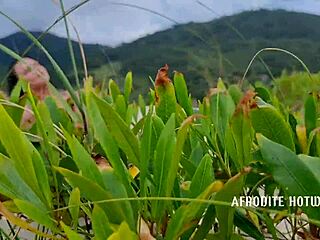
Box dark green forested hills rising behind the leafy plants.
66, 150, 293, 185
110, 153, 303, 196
0, 10, 320, 97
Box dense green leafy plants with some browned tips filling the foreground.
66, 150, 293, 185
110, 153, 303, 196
0, 0, 320, 240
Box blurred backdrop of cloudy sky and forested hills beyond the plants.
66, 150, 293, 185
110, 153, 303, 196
0, 0, 320, 98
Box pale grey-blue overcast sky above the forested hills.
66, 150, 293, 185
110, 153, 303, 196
0, 0, 320, 46
